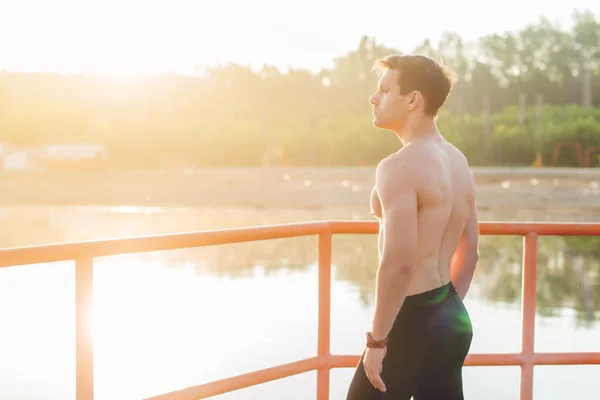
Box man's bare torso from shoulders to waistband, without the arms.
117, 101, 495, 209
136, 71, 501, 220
371, 136, 477, 295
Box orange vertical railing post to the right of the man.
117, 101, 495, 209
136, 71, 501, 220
521, 232, 538, 400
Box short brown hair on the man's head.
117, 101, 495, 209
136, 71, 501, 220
374, 54, 456, 116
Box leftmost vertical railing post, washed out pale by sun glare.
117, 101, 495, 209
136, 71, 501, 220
75, 257, 94, 400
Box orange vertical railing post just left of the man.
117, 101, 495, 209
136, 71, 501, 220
317, 230, 332, 400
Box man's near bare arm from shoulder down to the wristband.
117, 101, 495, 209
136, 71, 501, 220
371, 154, 417, 340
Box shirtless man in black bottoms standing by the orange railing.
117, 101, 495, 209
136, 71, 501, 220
347, 55, 479, 400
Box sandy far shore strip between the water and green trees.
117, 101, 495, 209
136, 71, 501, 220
0, 167, 600, 221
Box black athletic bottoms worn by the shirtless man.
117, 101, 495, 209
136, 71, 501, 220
346, 283, 473, 400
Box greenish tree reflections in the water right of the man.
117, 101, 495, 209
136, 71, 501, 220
477, 236, 600, 325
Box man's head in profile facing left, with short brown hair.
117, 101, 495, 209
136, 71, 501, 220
369, 55, 455, 132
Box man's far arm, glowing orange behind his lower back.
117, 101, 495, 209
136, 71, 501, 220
450, 203, 479, 299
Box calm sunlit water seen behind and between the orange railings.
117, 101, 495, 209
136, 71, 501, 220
0, 207, 600, 400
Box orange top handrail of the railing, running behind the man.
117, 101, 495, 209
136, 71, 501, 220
0, 221, 600, 267
